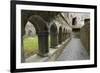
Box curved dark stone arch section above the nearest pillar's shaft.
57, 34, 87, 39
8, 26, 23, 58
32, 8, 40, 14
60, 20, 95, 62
28, 15, 48, 33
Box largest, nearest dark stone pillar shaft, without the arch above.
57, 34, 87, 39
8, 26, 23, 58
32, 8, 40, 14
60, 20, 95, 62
38, 31, 49, 57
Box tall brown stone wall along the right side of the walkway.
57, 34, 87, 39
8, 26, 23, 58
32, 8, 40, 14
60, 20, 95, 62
80, 19, 90, 54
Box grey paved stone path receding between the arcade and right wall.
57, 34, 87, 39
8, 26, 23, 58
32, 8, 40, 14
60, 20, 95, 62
57, 37, 89, 61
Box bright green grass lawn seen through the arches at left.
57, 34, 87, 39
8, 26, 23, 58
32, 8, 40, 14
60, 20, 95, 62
23, 36, 50, 58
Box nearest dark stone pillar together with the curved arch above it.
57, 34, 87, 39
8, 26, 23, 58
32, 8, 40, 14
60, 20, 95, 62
28, 15, 49, 56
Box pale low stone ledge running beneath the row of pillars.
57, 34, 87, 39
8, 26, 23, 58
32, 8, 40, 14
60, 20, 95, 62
25, 38, 71, 63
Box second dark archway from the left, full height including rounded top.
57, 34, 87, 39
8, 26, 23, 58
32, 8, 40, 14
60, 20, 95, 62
50, 24, 58, 48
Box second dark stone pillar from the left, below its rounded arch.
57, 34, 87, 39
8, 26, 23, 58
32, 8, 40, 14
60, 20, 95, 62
50, 32, 58, 48
